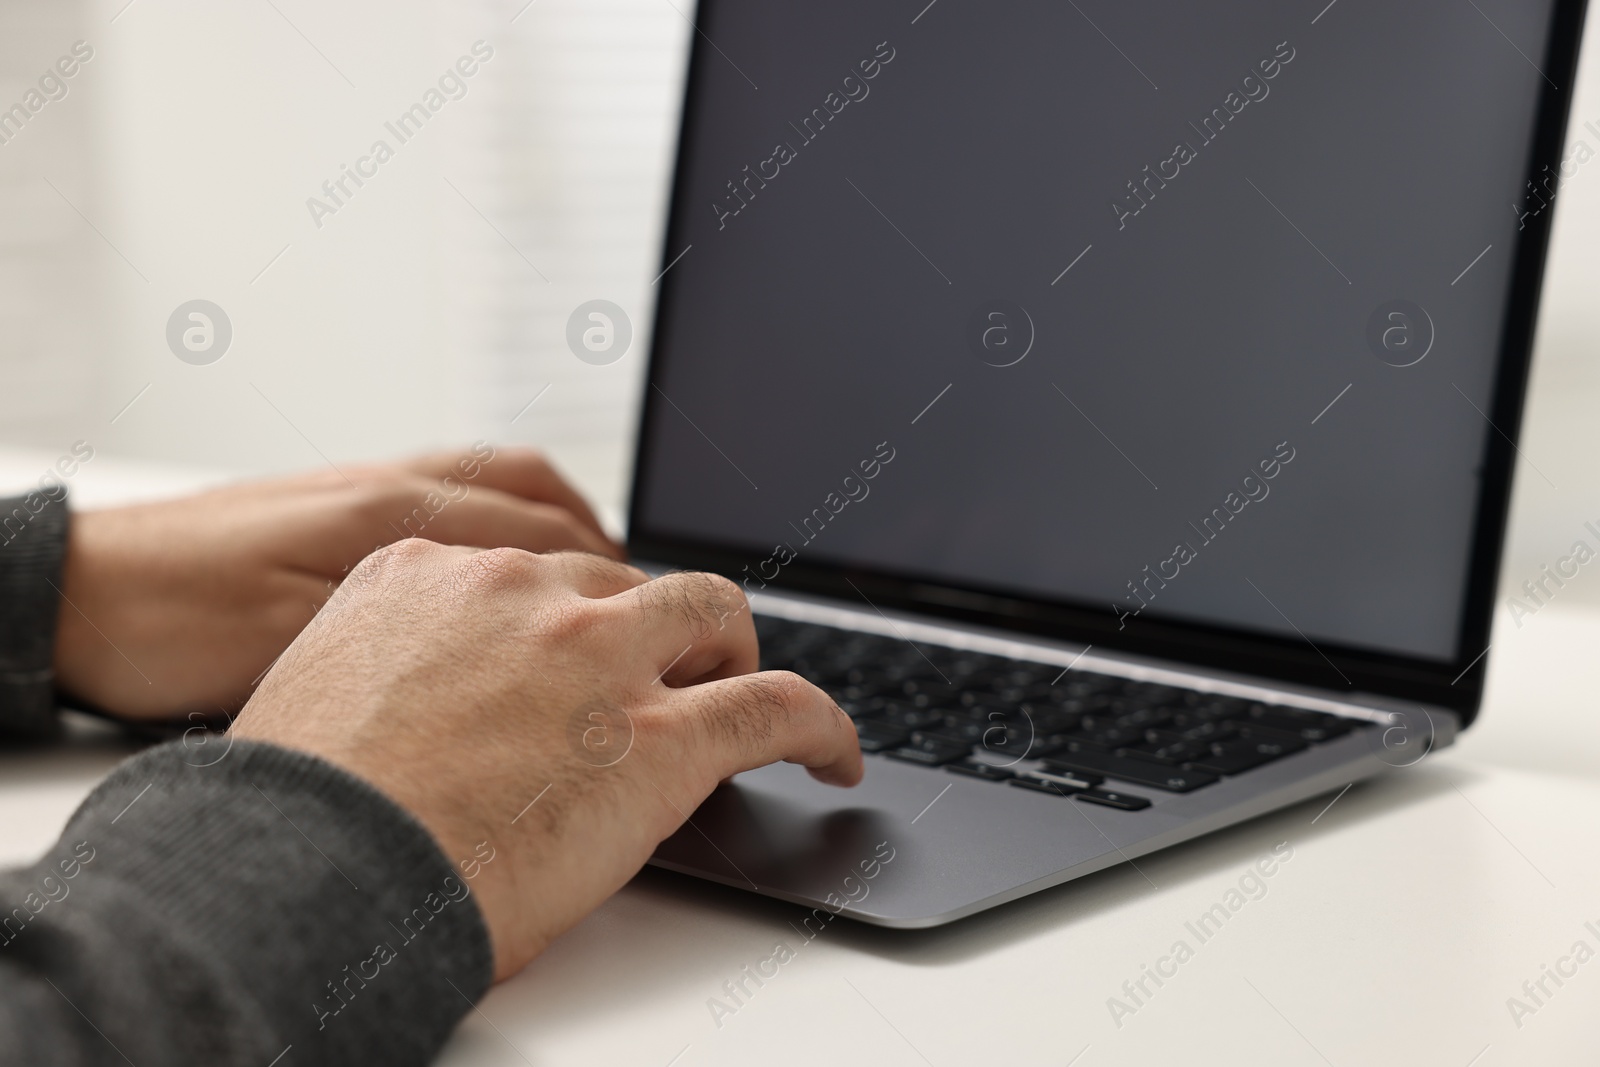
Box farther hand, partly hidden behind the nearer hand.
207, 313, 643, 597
56, 446, 621, 720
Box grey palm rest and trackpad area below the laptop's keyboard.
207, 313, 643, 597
651, 760, 1179, 926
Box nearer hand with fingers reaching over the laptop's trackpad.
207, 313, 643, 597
234, 541, 862, 979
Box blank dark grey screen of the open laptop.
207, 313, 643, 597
630, 0, 1576, 703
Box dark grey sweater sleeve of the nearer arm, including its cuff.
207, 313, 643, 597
0, 739, 493, 1067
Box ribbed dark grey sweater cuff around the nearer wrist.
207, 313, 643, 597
50, 737, 494, 1064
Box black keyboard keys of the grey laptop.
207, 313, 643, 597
755, 616, 1357, 811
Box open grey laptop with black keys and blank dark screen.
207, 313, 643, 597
629, 0, 1600, 928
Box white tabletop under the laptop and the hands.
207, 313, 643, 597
0, 461, 1600, 1067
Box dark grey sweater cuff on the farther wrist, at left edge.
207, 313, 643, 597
0, 488, 67, 736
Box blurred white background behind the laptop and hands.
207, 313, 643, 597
0, 0, 1600, 607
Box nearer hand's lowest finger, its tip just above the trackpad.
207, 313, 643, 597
674, 670, 864, 785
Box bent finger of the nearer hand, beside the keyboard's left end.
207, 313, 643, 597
605, 571, 760, 686
